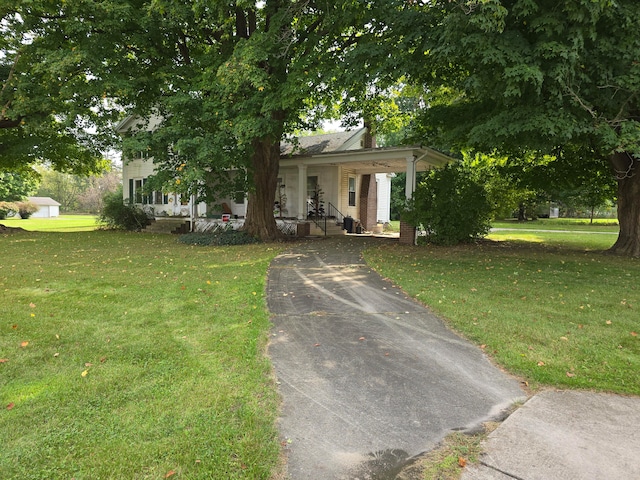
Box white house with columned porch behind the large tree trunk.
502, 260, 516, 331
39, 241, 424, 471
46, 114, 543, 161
118, 118, 452, 236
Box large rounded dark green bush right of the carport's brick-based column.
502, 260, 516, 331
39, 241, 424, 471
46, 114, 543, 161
402, 163, 491, 245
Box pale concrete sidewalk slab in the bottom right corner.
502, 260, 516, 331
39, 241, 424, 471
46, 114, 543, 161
462, 391, 640, 480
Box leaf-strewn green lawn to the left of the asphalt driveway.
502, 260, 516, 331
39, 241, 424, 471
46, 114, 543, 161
0, 230, 280, 479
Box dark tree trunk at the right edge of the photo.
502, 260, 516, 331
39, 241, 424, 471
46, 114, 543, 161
611, 152, 640, 257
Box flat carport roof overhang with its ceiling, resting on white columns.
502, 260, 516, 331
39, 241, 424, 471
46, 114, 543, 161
280, 147, 453, 175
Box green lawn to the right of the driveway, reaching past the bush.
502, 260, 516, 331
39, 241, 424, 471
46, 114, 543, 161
366, 226, 640, 395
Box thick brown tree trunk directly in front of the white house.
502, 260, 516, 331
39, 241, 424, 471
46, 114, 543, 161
244, 137, 281, 242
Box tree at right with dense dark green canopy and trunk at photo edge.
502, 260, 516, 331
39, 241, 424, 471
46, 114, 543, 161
404, 0, 640, 256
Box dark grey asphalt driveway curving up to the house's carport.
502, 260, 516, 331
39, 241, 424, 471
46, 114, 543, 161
267, 236, 526, 480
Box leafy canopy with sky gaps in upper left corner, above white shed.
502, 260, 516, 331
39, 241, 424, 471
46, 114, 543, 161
0, 0, 118, 174
